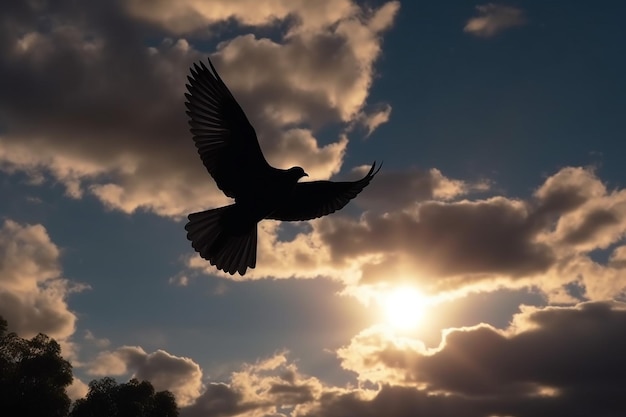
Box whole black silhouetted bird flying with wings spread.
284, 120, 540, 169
185, 59, 380, 275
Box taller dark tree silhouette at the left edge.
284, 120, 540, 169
0, 317, 72, 417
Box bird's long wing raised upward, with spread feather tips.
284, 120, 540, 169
185, 60, 269, 198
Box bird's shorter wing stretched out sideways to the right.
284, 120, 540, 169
267, 162, 382, 221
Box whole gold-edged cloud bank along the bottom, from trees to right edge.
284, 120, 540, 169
169, 301, 626, 417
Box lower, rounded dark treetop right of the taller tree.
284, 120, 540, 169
70, 377, 178, 417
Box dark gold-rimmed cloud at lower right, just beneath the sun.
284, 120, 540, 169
339, 302, 626, 390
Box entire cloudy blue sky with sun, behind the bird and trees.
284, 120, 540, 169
0, 0, 626, 417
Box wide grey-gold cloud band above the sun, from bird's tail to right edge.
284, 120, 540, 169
187, 167, 626, 303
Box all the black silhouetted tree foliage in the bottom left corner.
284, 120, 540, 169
0, 316, 178, 417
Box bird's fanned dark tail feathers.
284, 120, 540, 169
185, 205, 257, 275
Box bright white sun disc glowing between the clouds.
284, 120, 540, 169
382, 287, 425, 330
